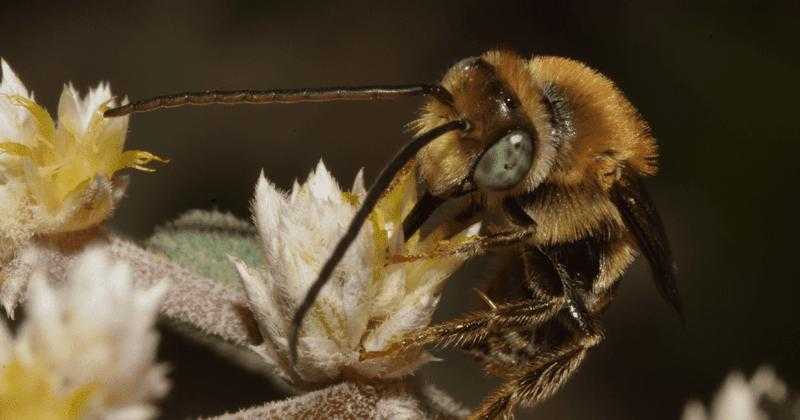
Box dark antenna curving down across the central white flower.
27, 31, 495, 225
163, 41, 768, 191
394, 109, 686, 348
289, 120, 469, 363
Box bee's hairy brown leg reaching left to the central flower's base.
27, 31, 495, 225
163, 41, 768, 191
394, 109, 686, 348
364, 297, 564, 359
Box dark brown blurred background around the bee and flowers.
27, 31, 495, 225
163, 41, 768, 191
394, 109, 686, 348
0, 1, 800, 419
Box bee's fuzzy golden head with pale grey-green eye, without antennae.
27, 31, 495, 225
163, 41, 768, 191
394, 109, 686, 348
419, 53, 551, 196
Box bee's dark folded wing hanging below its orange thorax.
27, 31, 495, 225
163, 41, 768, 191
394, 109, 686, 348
611, 173, 683, 320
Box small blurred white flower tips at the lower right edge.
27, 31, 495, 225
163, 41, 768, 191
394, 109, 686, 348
683, 367, 788, 420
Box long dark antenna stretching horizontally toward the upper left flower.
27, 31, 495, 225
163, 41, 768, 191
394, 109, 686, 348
103, 85, 453, 117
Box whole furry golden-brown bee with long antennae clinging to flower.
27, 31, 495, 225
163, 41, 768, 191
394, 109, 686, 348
106, 51, 682, 418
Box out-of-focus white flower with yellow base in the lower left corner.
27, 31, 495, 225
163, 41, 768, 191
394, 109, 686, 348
0, 248, 169, 419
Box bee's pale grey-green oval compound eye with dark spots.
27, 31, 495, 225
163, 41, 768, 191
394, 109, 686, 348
472, 130, 533, 190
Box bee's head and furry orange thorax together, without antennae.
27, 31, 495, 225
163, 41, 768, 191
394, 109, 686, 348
417, 51, 655, 201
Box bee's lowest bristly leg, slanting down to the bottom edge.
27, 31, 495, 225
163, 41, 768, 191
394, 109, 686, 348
471, 319, 603, 419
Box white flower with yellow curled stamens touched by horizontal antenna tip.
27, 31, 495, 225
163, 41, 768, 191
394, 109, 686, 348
0, 60, 166, 260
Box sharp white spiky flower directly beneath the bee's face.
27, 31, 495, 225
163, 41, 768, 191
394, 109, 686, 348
234, 162, 478, 386
